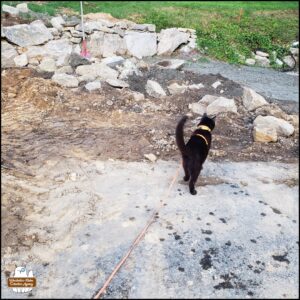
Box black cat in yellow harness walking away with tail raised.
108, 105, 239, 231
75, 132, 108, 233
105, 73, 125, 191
176, 114, 215, 195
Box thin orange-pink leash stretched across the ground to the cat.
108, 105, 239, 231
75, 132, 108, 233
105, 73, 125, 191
93, 164, 180, 299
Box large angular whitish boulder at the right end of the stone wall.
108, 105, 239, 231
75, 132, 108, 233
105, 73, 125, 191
157, 28, 190, 55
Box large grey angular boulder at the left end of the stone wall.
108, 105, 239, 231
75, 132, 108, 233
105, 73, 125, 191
3, 20, 53, 47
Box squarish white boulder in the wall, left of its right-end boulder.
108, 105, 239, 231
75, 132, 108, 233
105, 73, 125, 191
124, 31, 157, 59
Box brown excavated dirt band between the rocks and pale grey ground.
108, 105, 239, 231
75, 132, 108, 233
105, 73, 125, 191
1, 68, 299, 177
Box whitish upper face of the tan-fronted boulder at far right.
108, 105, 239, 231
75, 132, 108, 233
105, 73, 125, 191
253, 116, 295, 137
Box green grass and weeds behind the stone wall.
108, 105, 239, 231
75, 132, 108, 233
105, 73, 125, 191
2, 1, 299, 63
